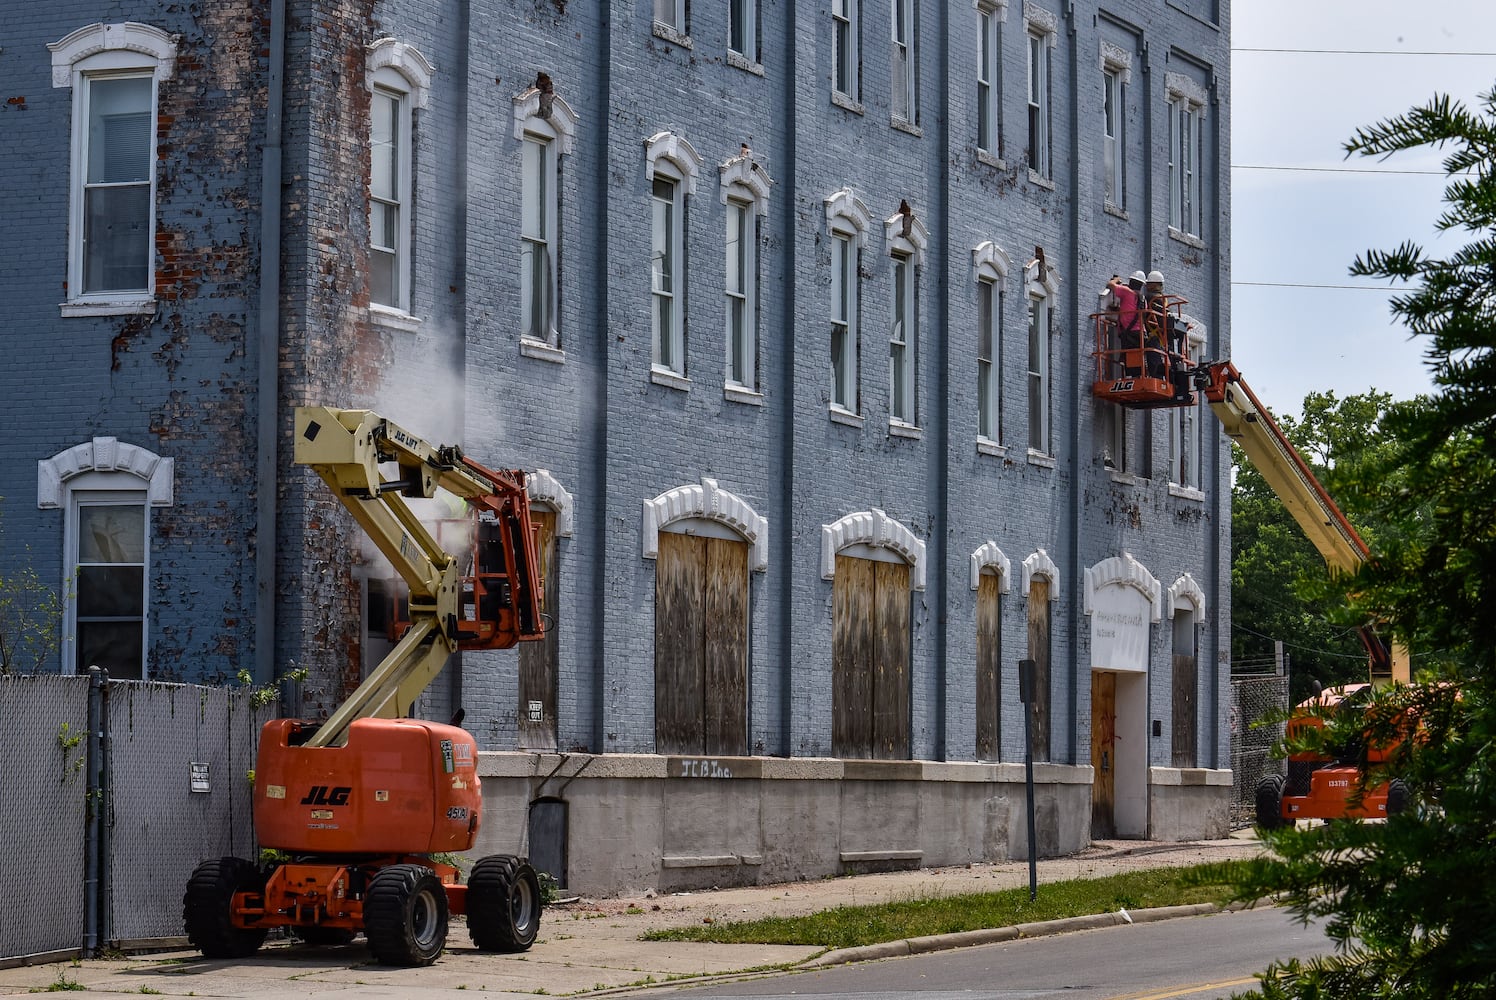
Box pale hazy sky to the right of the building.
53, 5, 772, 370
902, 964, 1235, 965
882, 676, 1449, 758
1231, 0, 1496, 415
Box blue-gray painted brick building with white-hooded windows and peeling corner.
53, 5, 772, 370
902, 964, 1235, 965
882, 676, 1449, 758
0, 0, 1230, 891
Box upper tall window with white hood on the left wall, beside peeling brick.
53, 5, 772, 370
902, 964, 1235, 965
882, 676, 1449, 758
48, 22, 177, 314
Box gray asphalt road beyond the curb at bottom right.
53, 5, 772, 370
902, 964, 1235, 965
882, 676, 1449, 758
634, 907, 1331, 1000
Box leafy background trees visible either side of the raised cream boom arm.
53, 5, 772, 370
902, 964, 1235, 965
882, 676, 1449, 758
1231, 392, 1391, 704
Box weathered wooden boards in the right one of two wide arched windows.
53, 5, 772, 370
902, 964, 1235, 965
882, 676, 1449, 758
832, 555, 910, 760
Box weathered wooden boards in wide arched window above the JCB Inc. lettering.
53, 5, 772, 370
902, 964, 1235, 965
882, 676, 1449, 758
655, 531, 748, 754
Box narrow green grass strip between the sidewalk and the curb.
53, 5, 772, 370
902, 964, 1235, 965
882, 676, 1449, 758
642, 865, 1231, 948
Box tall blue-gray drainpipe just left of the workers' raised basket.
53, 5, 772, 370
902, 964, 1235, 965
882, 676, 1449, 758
1065, 1, 1091, 763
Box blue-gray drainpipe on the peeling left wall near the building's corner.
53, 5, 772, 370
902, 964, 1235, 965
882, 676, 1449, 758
254, 0, 286, 686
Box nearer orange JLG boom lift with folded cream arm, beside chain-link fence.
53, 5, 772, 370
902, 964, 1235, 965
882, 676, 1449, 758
183, 407, 543, 966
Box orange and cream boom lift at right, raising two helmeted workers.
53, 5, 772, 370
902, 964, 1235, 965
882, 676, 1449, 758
1092, 305, 1411, 826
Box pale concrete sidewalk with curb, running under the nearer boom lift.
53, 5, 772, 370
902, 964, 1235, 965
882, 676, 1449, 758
0, 831, 1258, 1000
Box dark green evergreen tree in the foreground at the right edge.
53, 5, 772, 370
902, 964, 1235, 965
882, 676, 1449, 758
1220, 96, 1496, 1000
